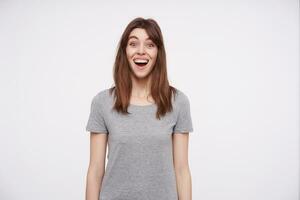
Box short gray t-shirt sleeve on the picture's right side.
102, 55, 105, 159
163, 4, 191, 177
173, 94, 193, 133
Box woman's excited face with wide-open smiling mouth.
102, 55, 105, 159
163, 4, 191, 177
126, 28, 158, 79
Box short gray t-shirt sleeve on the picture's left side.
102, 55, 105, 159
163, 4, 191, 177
86, 96, 108, 134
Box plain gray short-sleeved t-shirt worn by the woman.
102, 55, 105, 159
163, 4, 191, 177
86, 89, 193, 200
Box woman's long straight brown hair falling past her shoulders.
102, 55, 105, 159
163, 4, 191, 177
109, 17, 176, 119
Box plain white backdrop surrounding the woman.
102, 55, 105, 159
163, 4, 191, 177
0, 0, 299, 200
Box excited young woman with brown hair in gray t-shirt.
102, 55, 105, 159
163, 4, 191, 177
86, 18, 193, 200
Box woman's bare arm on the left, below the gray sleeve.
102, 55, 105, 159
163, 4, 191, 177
86, 132, 107, 200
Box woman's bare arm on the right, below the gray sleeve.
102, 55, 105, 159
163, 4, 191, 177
172, 133, 192, 200
